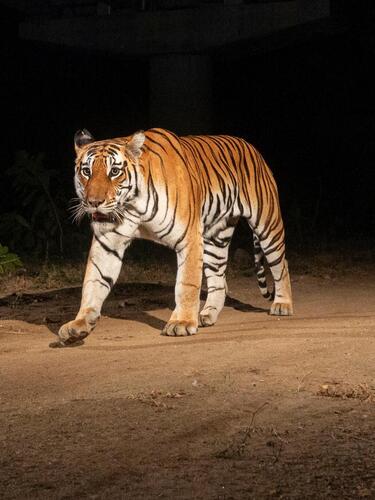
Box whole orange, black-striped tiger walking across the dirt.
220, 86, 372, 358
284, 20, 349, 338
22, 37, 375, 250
57, 128, 293, 347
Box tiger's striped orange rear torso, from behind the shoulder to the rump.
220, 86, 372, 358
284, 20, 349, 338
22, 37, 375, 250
181, 131, 277, 230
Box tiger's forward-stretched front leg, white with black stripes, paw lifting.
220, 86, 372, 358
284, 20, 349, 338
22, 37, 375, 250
51, 233, 131, 347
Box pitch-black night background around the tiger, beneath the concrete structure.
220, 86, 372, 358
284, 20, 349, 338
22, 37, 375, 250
0, 2, 375, 258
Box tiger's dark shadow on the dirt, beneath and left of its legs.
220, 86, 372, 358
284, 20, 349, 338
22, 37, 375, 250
0, 283, 268, 335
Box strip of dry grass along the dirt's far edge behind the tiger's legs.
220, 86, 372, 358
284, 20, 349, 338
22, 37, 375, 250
0, 246, 375, 296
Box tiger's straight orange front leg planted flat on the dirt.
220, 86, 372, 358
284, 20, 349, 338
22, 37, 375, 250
162, 235, 203, 336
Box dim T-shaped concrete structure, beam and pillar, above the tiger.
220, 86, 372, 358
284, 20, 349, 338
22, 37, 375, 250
11, 0, 330, 133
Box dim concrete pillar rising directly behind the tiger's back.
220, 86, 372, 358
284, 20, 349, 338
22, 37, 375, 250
150, 54, 212, 135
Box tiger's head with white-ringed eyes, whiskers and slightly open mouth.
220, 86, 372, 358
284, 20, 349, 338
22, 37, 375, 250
74, 129, 145, 223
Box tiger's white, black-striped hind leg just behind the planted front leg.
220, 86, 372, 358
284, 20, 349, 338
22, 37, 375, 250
199, 226, 234, 326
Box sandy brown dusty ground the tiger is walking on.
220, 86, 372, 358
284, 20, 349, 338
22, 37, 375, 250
0, 262, 375, 499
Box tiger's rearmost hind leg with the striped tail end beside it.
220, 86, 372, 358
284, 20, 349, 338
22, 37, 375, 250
253, 224, 293, 316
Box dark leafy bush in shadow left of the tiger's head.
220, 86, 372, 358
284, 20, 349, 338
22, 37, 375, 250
0, 151, 88, 262
